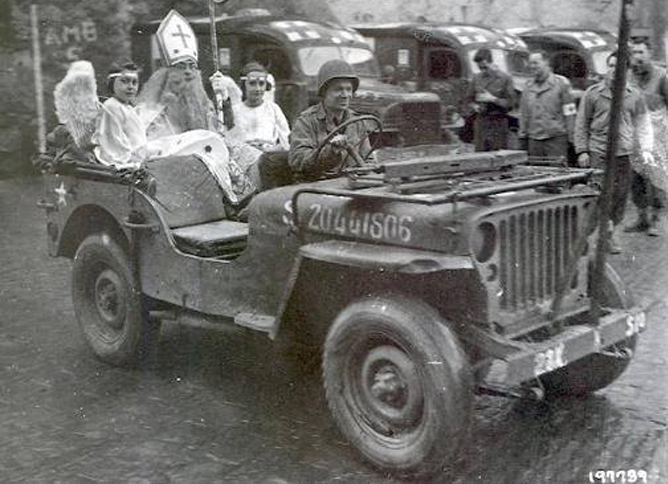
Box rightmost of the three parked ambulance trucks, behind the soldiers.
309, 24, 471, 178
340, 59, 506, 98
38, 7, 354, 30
516, 28, 617, 99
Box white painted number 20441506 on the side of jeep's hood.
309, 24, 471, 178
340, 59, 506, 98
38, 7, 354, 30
306, 203, 413, 244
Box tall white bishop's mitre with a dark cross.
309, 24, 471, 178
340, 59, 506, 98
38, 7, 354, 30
156, 10, 197, 66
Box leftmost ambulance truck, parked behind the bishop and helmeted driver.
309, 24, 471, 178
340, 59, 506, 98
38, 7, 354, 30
132, 11, 445, 146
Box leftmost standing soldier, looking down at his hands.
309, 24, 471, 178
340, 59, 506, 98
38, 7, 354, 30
466, 49, 517, 151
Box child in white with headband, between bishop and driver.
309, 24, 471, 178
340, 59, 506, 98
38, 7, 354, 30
230, 62, 290, 151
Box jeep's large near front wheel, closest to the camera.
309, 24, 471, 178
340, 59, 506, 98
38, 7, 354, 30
323, 297, 473, 477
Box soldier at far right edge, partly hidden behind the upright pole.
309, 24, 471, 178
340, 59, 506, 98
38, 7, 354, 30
624, 42, 668, 237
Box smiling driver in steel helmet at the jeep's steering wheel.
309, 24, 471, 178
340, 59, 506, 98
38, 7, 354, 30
289, 60, 371, 181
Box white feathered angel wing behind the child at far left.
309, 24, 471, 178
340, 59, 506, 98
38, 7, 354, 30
53, 61, 100, 148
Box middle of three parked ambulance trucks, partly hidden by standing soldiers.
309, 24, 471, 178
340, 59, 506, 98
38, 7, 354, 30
353, 22, 529, 136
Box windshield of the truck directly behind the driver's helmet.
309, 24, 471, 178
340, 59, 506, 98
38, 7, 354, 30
297, 45, 380, 77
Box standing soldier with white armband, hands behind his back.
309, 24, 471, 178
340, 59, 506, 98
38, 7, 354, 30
519, 51, 577, 158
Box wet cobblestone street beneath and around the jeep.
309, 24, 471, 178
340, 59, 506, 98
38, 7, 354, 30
0, 178, 668, 484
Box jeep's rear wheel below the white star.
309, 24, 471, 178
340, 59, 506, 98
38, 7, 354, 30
72, 234, 160, 365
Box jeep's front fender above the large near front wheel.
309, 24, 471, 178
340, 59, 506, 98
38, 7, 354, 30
270, 240, 475, 341
